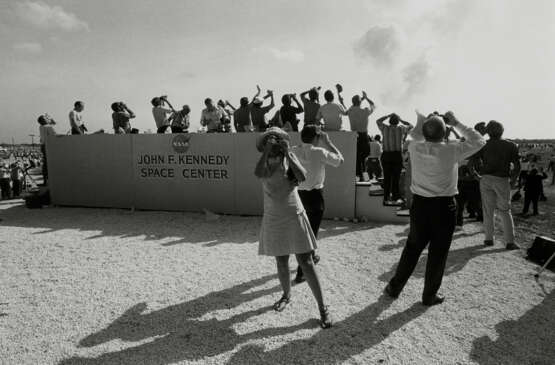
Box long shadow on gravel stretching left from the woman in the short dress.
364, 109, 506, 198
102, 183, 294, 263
60, 275, 318, 365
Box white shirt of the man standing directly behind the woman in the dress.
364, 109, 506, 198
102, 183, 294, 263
291, 143, 343, 190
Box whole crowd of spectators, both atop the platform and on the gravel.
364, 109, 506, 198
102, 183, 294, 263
27, 84, 555, 328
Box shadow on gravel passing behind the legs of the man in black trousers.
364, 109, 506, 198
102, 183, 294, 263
378, 245, 507, 282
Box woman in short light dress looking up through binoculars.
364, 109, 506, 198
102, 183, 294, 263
255, 127, 331, 328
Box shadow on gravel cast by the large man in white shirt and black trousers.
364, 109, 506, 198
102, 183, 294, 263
229, 295, 426, 365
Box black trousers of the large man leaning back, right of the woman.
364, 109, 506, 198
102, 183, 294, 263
389, 194, 457, 300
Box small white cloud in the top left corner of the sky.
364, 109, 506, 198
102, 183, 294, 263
15, 1, 89, 31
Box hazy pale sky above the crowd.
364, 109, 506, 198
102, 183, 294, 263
0, 0, 555, 143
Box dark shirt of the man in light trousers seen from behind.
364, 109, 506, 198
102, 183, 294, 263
479, 138, 518, 177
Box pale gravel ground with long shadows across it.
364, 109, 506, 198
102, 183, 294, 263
0, 186, 555, 365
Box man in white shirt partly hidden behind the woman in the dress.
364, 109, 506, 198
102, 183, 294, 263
292, 124, 343, 283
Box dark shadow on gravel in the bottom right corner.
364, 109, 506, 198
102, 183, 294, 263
470, 291, 555, 365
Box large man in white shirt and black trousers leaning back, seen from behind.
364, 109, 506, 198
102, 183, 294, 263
385, 112, 486, 306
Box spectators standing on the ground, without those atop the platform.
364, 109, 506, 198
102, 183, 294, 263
255, 107, 555, 328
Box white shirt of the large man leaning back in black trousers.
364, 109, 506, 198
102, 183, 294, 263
408, 114, 486, 197
